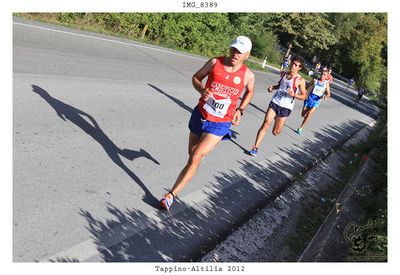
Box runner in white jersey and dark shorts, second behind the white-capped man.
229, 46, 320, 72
249, 57, 307, 156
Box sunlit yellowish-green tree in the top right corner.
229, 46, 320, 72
325, 13, 387, 96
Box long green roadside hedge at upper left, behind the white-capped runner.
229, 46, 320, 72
21, 13, 280, 63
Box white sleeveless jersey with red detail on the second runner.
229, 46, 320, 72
272, 72, 301, 110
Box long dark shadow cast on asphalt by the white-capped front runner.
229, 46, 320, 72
32, 85, 160, 208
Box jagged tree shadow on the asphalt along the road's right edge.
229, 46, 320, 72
66, 122, 372, 262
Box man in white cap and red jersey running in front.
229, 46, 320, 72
160, 36, 254, 210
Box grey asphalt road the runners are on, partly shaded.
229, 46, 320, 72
13, 18, 377, 262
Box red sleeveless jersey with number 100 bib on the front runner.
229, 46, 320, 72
198, 57, 247, 122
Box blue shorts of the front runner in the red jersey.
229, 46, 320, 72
189, 106, 232, 139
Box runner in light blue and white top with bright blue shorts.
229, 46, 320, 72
297, 71, 331, 135
